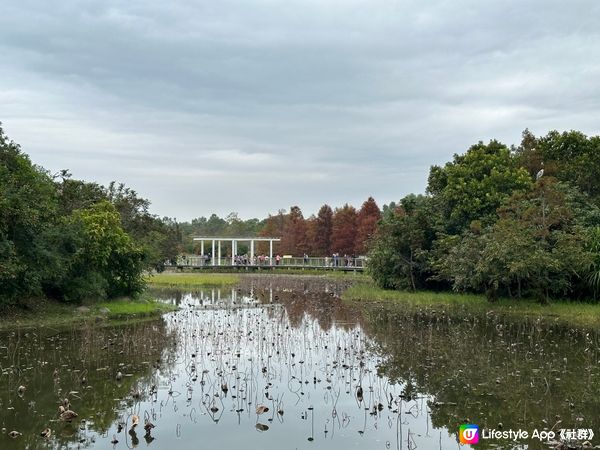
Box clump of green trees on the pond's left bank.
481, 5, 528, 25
0, 123, 181, 306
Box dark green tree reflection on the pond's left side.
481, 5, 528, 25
0, 320, 175, 449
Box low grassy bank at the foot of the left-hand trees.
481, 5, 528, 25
0, 298, 176, 330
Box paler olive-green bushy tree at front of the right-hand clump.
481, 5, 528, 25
436, 178, 591, 302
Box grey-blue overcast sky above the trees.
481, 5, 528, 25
0, 0, 600, 220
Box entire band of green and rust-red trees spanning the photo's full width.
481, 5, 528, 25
0, 123, 600, 305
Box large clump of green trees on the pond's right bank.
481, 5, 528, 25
369, 130, 600, 302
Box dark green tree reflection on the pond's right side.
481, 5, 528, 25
366, 309, 600, 447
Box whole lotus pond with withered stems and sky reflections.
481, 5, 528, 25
0, 278, 600, 450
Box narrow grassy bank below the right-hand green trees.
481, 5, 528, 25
342, 282, 600, 328
